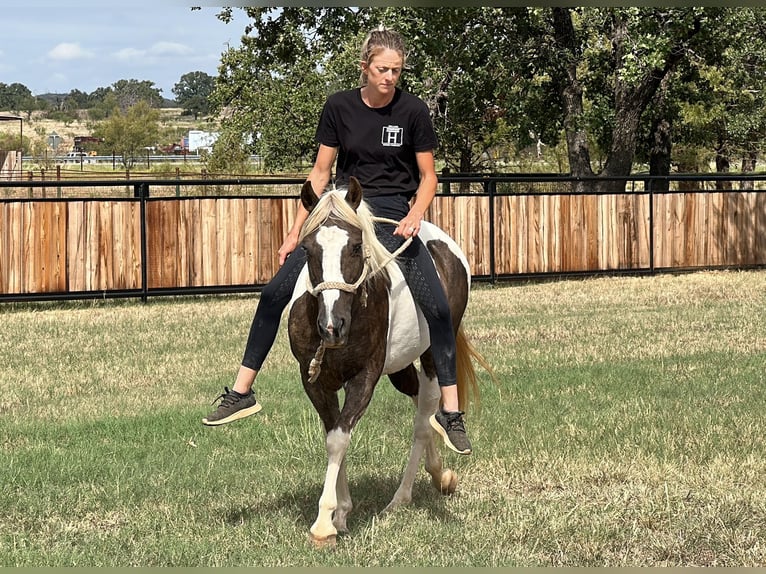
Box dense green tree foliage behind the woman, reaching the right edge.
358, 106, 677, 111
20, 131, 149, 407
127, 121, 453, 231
213, 7, 766, 176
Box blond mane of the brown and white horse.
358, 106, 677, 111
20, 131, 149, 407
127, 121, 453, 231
299, 188, 391, 277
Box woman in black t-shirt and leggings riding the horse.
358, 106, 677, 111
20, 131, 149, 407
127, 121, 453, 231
207, 29, 471, 454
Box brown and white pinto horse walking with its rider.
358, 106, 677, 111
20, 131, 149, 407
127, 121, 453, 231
288, 177, 487, 546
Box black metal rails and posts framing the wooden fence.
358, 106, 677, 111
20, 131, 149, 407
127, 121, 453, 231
0, 174, 766, 302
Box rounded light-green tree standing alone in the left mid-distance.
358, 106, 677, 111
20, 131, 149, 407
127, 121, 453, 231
93, 101, 160, 169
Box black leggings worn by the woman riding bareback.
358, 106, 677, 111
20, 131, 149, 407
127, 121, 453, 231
242, 207, 457, 387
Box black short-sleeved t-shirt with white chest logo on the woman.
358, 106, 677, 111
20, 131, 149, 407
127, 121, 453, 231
316, 88, 437, 199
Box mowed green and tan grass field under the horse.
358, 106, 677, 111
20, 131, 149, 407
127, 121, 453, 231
0, 271, 766, 567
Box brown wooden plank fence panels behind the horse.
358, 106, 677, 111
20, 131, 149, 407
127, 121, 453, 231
0, 177, 766, 301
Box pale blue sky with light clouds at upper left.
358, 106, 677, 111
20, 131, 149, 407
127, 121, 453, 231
0, 0, 246, 99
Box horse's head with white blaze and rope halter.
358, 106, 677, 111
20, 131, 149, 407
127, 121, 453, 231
301, 177, 369, 347
